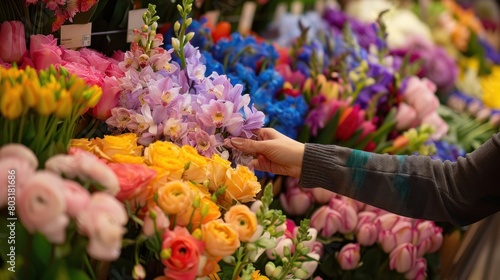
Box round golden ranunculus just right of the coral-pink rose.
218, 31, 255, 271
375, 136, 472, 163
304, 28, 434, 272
158, 181, 193, 215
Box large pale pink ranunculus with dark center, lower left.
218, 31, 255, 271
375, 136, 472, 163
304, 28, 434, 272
16, 171, 69, 244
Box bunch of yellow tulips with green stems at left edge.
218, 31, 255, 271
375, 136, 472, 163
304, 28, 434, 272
0, 66, 102, 166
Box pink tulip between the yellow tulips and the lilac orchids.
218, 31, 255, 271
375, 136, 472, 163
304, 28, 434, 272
92, 77, 121, 120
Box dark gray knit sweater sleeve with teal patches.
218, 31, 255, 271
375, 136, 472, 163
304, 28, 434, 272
300, 133, 500, 225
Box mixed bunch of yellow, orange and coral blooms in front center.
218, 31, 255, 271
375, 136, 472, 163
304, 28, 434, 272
72, 133, 319, 279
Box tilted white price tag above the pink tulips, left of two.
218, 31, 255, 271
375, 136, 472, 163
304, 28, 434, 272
61, 22, 92, 49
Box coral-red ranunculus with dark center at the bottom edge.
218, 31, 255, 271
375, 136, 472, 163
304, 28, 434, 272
162, 227, 205, 279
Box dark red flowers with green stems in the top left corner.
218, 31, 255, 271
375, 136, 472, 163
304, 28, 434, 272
0, 0, 98, 34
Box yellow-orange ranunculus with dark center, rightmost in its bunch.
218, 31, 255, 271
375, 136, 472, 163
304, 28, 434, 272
224, 204, 257, 242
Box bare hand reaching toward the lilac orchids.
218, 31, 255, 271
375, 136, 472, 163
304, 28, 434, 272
231, 128, 304, 178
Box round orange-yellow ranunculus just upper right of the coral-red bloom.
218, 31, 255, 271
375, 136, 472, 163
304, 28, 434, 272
201, 220, 240, 258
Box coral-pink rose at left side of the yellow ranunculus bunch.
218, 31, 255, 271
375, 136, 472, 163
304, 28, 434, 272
108, 163, 157, 208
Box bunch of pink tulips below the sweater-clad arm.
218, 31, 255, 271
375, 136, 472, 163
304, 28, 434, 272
280, 178, 443, 279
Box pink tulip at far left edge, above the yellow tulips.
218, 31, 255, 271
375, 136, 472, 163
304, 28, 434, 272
0, 21, 26, 65
